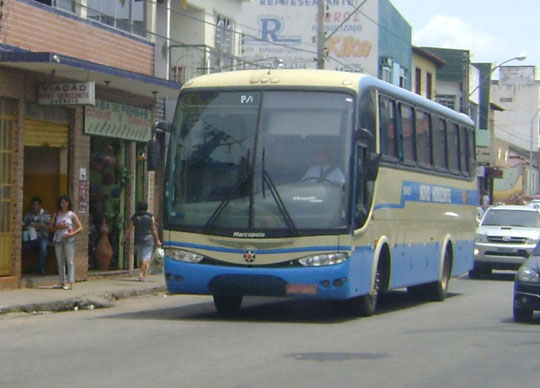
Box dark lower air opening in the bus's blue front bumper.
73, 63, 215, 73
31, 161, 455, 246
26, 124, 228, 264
208, 275, 287, 296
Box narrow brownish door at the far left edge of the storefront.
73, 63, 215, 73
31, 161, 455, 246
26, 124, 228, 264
0, 99, 15, 276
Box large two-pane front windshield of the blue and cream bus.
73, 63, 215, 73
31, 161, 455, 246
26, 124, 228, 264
165, 90, 354, 236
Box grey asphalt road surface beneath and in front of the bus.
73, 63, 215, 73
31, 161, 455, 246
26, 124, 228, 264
0, 274, 540, 388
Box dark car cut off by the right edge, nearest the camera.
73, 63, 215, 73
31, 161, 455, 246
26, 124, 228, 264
513, 244, 540, 322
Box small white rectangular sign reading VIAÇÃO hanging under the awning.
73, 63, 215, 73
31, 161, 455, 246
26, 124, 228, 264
38, 81, 96, 105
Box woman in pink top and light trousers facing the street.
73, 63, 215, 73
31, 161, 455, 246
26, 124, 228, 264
49, 195, 83, 290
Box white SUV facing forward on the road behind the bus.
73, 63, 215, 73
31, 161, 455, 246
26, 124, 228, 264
469, 205, 540, 278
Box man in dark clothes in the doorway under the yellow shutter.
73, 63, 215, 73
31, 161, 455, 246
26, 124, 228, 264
23, 197, 51, 275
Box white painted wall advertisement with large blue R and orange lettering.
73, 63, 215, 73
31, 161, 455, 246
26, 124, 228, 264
239, 0, 379, 77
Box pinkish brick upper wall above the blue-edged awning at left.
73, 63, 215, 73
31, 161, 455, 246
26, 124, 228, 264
4, 0, 154, 75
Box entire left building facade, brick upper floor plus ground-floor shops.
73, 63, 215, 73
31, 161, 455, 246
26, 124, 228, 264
0, 0, 179, 289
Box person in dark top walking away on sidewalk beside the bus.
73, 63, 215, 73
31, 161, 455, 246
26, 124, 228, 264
122, 202, 161, 282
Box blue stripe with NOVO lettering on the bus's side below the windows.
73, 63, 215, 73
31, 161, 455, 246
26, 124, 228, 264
374, 181, 480, 210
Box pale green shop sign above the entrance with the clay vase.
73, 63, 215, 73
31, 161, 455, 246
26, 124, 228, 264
84, 100, 152, 142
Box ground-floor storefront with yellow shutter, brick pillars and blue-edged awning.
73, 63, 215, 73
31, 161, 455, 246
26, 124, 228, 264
0, 53, 179, 289
